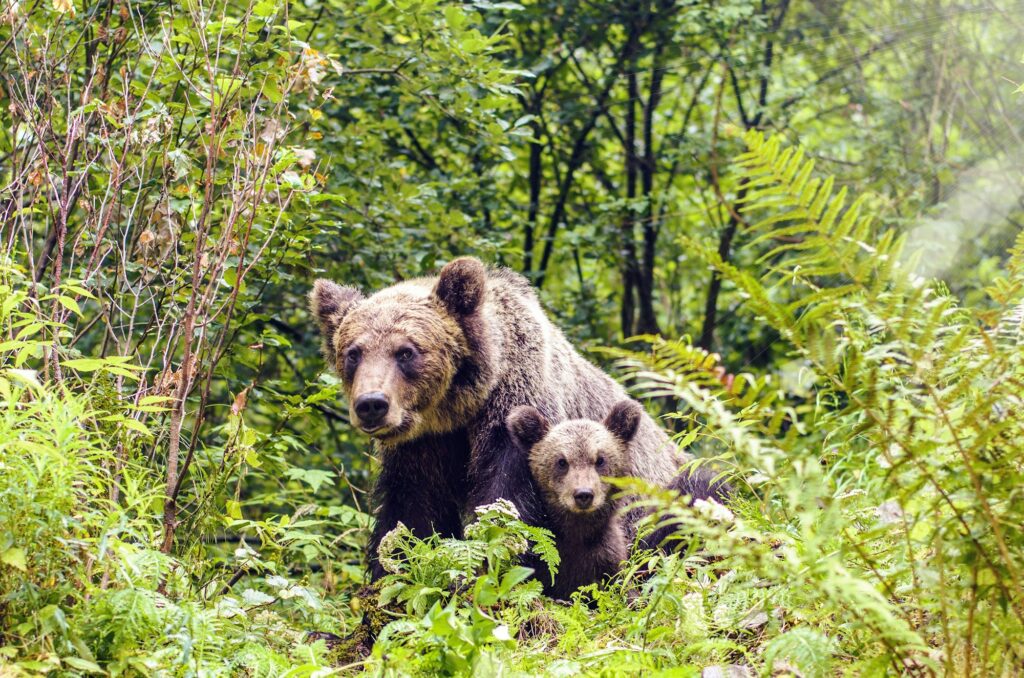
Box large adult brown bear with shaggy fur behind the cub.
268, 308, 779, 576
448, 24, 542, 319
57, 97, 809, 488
310, 258, 681, 579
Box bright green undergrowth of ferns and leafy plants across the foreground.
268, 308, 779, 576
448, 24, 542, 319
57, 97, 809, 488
0, 131, 1024, 677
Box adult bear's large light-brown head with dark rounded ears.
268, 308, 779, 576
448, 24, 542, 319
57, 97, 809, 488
309, 258, 493, 443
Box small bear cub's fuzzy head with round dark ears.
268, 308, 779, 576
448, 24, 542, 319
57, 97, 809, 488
506, 400, 643, 516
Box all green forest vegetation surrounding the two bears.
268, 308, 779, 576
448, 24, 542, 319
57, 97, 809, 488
0, 0, 1024, 676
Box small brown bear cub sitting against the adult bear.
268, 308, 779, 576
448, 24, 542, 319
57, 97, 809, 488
506, 400, 643, 599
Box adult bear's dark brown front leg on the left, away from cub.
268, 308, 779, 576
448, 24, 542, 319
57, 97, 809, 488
367, 431, 469, 581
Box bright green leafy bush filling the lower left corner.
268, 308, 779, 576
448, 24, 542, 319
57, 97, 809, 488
0, 263, 343, 675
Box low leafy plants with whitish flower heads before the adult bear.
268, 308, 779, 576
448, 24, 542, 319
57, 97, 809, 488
374, 500, 558, 675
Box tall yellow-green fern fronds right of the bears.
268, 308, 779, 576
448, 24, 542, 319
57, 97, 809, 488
623, 132, 1024, 673
